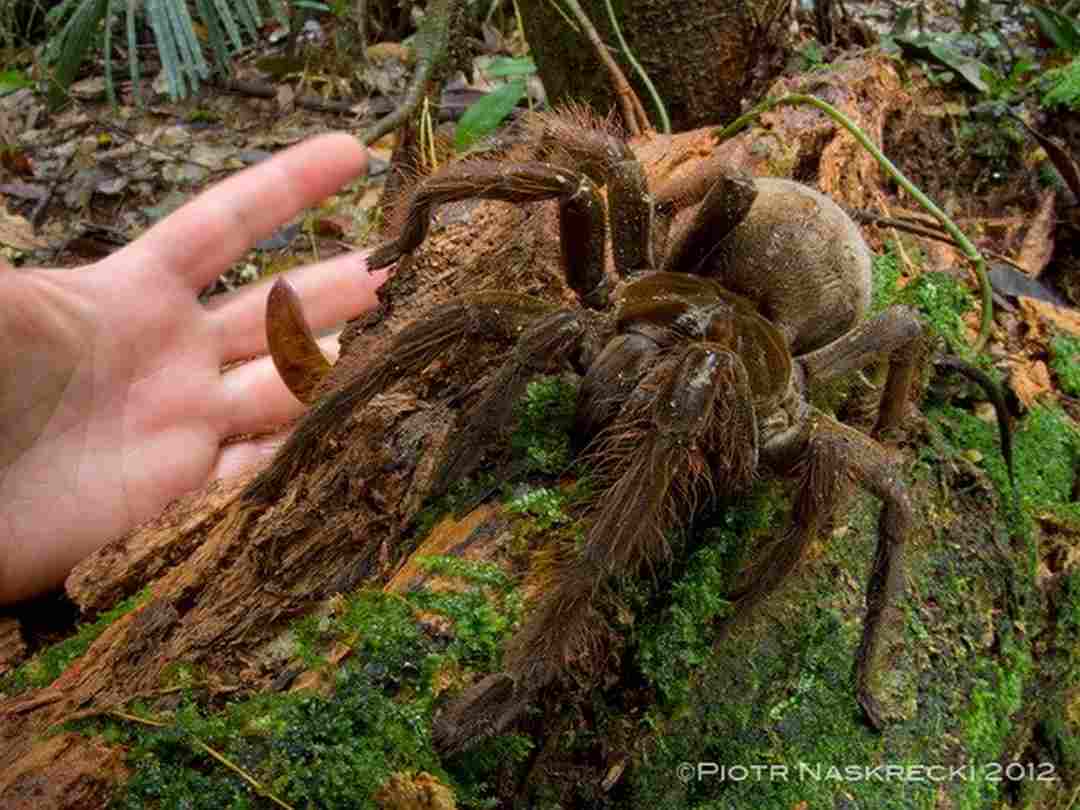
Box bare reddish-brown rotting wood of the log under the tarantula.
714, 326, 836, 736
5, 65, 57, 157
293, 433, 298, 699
0, 60, 905, 807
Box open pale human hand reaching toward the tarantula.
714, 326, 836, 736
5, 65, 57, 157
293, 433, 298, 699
0, 133, 384, 604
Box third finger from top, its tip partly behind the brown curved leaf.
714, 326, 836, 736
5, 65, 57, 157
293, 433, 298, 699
221, 335, 338, 436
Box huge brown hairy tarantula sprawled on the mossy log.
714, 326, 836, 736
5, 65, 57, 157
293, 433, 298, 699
245, 109, 921, 748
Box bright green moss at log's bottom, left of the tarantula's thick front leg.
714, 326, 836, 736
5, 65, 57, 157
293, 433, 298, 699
78, 557, 529, 810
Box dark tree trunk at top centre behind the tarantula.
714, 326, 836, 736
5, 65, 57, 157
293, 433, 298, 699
519, 0, 789, 132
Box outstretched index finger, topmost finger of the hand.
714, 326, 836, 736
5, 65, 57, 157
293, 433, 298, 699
110, 133, 367, 291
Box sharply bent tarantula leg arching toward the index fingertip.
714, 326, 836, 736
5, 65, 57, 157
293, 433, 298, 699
367, 160, 644, 309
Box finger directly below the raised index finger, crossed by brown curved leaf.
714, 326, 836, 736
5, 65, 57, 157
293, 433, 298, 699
207, 253, 387, 362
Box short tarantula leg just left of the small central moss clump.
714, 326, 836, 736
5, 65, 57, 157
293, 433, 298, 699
429, 310, 586, 495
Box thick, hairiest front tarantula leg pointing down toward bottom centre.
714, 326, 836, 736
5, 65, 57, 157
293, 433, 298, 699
434, 343, 756, 752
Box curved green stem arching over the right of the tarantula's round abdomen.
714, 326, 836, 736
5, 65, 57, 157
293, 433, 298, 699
717, 93, 994, 353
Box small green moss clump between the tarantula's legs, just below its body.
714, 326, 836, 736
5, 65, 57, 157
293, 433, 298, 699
510, 377, 578, 475
